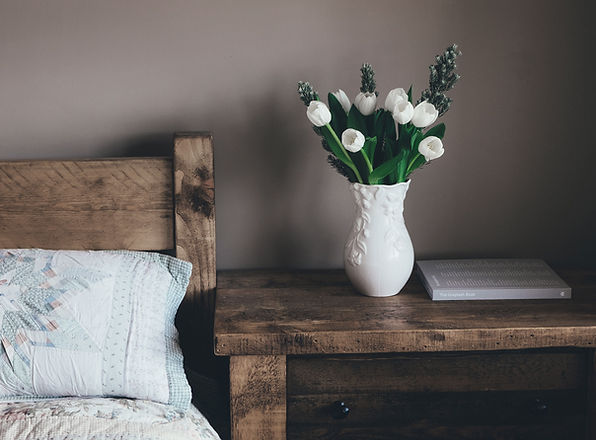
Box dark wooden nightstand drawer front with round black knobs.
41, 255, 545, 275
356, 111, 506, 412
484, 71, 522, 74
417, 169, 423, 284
287, 351, 587, 439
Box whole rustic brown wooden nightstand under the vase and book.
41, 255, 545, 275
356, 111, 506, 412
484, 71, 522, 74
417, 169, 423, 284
215, 271, 596, 440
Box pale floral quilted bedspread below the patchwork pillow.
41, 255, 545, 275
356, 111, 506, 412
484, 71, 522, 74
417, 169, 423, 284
0, 397, 219, 440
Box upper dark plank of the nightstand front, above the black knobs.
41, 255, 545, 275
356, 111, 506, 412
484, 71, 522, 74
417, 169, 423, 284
287, 351, 586, 395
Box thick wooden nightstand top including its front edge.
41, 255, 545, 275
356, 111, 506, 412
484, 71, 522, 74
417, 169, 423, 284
215, 271, 596, 355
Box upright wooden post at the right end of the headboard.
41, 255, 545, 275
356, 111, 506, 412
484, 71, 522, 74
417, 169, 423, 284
174, 133, 216, 372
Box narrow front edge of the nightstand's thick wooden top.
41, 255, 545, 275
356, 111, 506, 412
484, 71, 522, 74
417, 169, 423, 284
215, 322, 596, 356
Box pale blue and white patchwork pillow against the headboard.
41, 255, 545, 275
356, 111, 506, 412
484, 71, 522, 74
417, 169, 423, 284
0, 249, 192, 410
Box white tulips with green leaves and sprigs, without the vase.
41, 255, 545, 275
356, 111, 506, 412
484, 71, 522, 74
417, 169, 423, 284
298, 44, 461, 185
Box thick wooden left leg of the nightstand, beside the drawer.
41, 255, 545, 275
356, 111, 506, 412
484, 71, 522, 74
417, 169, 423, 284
230, 356, 286, 440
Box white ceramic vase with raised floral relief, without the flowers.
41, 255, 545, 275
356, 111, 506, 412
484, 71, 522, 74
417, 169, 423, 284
344, 180, 414, 296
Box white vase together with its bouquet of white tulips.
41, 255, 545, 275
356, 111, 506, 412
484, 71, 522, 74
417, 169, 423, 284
298, 44, 461, 296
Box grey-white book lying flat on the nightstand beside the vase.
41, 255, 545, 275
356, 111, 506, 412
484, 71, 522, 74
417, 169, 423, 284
416, 259, 571, 301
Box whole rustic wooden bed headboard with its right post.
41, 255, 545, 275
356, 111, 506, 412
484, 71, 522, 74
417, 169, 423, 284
0, 133, 216, 374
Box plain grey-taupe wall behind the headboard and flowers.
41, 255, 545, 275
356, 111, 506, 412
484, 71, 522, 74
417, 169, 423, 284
0, 0, 596, 269
